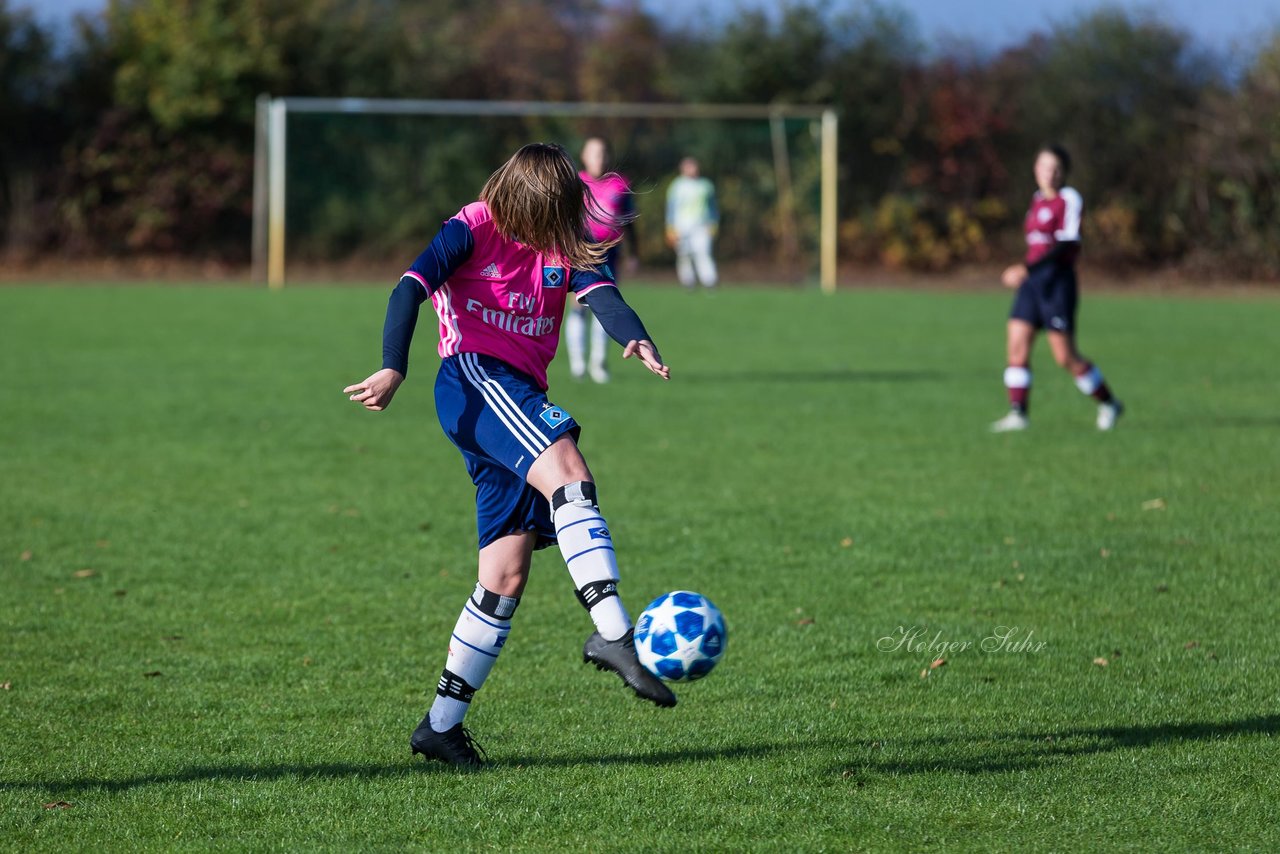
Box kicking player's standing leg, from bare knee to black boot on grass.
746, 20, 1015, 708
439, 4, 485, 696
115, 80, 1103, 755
410, 531, 538, 767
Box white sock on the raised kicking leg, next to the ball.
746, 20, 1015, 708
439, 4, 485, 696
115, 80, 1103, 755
552, 480, 631, 640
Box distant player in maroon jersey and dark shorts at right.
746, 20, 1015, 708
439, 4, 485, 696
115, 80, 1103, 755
991, 145, 1124, 433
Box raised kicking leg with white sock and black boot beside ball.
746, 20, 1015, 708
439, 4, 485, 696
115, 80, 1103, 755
527, 434, 676, 705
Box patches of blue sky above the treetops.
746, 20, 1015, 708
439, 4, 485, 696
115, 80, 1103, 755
10, 0, 1280, 51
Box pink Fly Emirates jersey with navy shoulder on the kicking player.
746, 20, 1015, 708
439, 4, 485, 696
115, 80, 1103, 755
404, 202, 616, 389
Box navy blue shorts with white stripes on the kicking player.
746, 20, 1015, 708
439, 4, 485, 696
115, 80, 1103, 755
435, 353, 581, 548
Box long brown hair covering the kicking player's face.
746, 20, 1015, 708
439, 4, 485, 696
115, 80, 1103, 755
480, 142, 630, 270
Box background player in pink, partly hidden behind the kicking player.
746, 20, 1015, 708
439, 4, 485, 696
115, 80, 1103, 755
564, 137, 639, 383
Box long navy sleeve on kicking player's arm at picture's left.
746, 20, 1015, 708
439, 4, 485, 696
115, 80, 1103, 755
383, 219, 475, 376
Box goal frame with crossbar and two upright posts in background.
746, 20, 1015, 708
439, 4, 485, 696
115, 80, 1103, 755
252, 96, 838, 293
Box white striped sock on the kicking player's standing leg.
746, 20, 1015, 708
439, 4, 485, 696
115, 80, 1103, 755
429, 584, 520, 732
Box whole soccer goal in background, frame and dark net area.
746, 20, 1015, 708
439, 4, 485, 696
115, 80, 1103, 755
253, 99, 836, 288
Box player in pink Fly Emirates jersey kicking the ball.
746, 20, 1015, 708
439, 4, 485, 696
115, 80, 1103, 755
343, 143, 676, 767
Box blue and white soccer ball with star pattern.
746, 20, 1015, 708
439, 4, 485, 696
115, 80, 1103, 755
636, 590, 728, 682
